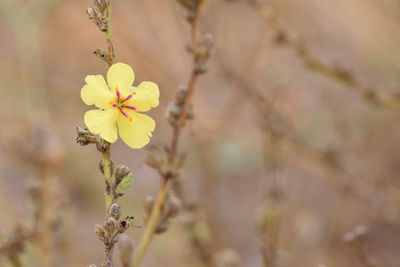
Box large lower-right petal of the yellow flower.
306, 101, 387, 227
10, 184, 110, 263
117, 111, 156, 149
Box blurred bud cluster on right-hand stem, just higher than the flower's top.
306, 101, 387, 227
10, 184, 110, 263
187, 33, 214, 74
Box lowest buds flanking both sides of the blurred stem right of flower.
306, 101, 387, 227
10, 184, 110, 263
143, 196, 182, 234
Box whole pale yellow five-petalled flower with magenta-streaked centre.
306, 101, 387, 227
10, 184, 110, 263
81, 63, 160, 148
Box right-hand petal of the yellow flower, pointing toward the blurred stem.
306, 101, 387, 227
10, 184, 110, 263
127, 82, 160, 112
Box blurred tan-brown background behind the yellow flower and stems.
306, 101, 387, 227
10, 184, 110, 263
0, 0, 400, 267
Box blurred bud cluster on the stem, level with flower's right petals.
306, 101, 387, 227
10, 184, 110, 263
166, 85, 194, 126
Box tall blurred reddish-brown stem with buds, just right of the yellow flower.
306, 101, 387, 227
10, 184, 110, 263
133, 0, 211, 267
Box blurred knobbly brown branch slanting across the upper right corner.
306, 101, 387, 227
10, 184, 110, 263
247, 0, 400, 110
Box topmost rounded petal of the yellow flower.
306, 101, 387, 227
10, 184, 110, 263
107, 63, 135, 97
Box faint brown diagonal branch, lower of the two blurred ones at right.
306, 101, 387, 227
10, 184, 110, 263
220, 50, 398, 230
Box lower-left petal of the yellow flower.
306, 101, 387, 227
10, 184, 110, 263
84, 108, 120, 143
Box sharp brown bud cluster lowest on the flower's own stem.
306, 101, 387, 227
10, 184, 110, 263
96, 203, 133, 248
